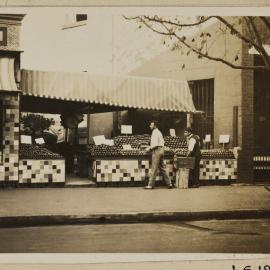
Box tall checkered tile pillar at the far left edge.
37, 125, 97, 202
0, 93, 19, 181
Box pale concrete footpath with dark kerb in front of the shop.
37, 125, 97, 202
0, 185, 270, 227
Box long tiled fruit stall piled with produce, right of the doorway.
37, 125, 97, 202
89, 135, 237, 185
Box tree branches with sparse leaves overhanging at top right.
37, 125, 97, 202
124, 15, 270, 71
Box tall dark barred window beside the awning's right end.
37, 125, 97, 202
189, 79, 214, 140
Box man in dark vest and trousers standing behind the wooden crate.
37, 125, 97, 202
184, 128, 201, 188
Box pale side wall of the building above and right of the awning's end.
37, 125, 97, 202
127, 17, 242, 146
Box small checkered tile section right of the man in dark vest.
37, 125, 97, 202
200, 159, 237, 180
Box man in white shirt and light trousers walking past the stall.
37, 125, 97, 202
144, 121, 173, 189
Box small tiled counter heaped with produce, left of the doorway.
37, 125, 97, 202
19, 144, 65, 184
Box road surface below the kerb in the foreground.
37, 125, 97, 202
0, 219, 270, 253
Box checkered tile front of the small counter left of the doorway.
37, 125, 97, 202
19, 159, 65, 184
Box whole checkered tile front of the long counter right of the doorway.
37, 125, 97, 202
93, 158, 237, 183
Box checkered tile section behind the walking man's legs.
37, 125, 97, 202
95, 159, 175, 182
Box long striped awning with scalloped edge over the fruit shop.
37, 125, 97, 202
20, 70, 196, 112
